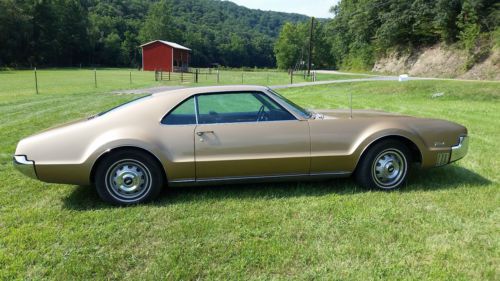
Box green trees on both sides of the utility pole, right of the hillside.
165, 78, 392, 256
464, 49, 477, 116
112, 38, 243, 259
274, 0, 500, 69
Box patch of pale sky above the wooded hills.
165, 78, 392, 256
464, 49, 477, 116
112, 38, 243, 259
230, 0, 340, 18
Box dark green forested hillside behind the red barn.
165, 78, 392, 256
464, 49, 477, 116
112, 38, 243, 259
0, 0, 307, 67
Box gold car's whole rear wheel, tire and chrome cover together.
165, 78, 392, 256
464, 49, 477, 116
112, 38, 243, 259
95, 150, 165, 205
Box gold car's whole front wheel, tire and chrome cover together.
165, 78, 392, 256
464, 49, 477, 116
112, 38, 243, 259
355, 140, 411, 190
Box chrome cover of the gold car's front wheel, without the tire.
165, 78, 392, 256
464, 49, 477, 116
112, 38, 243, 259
372, 148, 407, 189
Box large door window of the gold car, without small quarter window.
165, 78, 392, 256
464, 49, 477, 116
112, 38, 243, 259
198, 92, 295, 124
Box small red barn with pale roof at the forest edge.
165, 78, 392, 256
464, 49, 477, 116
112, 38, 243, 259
141, 40, 191, 72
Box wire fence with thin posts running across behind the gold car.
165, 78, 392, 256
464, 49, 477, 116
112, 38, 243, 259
0, 68, 324, 94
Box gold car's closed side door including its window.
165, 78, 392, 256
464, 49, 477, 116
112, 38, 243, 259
194, 92, 310, 181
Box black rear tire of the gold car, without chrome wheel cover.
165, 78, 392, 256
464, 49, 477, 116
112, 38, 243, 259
95, 150, 165, 205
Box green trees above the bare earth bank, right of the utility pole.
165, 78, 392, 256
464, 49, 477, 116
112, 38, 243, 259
328, 0, 500, 69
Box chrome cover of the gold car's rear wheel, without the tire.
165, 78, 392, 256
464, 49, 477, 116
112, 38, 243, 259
106, 159, 152, 202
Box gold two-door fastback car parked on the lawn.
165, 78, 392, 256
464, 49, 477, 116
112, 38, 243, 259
14, 86, 468, 205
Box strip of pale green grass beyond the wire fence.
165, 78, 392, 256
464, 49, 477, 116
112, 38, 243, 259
0, 69, 363, 98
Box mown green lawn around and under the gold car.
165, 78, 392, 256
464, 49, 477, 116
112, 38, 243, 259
0, 68, 500, 280
